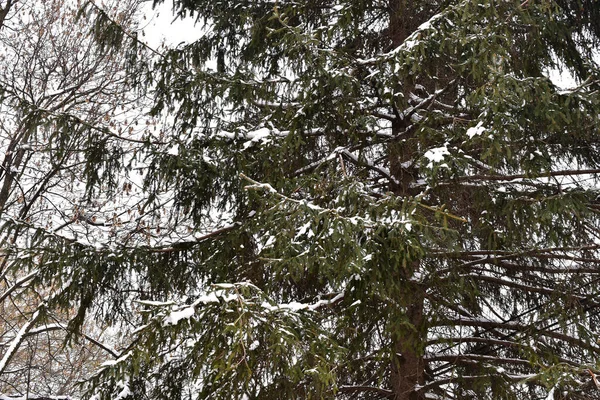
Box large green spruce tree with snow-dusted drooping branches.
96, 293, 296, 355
3, 0, 600, 400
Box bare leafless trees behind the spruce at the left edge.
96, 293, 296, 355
0, 0, 147, 399
